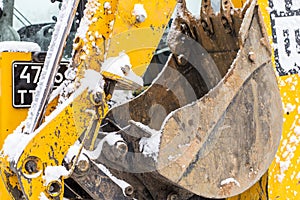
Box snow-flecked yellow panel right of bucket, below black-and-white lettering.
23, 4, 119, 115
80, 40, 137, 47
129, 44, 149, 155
269, 75, 300, 199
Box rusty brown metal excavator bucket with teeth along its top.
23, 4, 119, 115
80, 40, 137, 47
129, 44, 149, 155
99, 0, 282, 199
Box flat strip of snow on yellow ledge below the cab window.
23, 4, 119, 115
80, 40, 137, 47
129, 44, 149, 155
0, 41, 41, 53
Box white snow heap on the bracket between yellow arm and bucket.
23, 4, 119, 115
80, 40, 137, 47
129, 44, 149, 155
102, 52, 143, 86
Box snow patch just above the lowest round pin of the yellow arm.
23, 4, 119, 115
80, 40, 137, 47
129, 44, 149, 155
43, 166, 69, 186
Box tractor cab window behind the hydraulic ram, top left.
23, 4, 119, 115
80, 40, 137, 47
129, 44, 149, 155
0, 0, 82, 59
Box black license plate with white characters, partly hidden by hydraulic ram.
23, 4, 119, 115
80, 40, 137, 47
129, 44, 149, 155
12, 62, 68, 108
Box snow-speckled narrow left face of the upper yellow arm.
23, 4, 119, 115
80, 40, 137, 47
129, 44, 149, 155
73, 0, 118, 72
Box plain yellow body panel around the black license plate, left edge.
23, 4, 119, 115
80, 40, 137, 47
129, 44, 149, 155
0, 52, 31, 199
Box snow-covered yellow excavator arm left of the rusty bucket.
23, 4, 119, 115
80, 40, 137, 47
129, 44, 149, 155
1, 0, 176, 199
